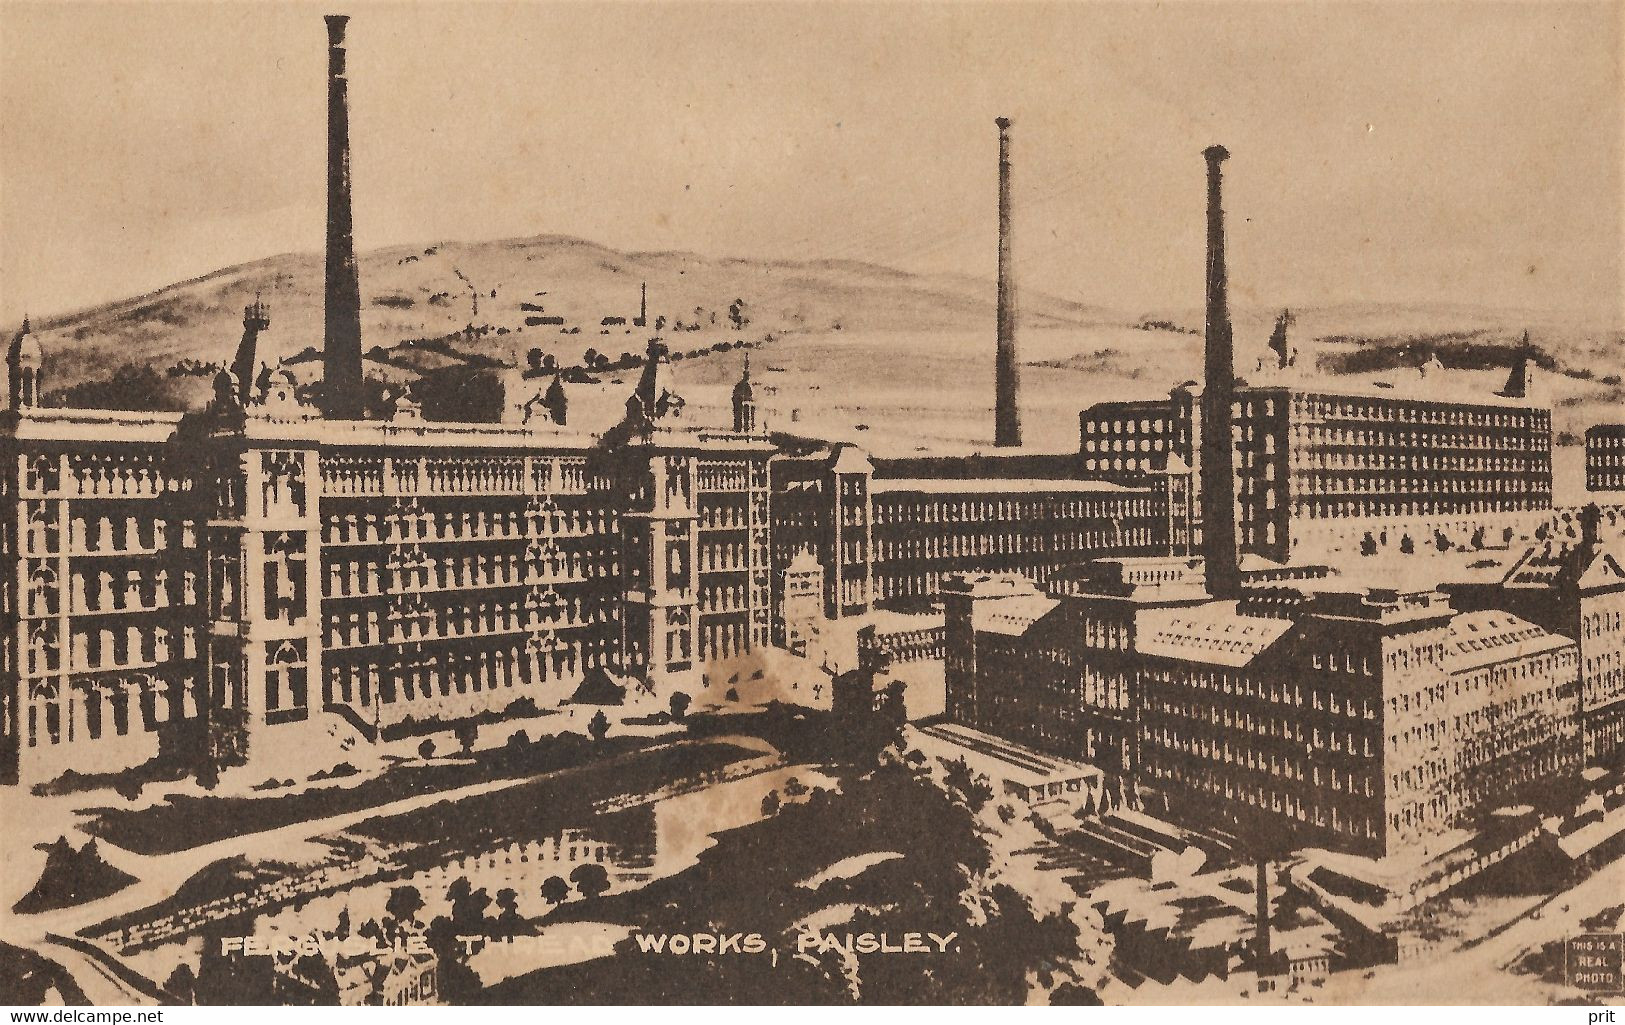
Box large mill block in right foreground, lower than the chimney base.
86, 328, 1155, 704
944, 559, 1581, 858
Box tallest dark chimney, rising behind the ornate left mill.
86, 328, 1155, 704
322, 15, 362, 421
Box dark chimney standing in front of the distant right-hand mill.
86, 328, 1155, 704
1201, 146, 1240, 598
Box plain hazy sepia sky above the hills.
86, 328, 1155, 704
0, 0, 1625, 323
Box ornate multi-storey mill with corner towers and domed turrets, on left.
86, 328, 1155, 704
0, 310, 774, 781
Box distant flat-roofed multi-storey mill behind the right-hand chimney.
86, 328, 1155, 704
1079, 370, 1552, 562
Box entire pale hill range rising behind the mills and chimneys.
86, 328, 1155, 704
13, 236, 1625, 484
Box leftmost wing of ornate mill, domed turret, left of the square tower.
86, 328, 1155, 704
0, 322, 206, 778
